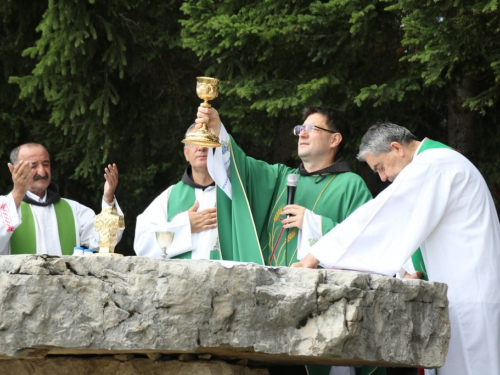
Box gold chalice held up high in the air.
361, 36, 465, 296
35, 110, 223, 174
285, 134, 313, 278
182, 77, 220, 147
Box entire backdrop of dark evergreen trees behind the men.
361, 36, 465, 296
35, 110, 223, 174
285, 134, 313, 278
0, 0, 500, 254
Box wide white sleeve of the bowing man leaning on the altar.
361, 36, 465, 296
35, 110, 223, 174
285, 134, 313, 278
310, 161, 452, 276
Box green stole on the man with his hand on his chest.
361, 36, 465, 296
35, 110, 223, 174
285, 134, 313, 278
167, 181, 226, 260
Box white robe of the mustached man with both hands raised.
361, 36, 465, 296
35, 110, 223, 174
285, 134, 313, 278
0, 192, 123, 255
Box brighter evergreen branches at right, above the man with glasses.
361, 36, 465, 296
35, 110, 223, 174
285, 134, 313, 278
182, 0, 500, 197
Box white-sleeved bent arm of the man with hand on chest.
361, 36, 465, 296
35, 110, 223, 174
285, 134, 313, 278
134, 186, 196, 258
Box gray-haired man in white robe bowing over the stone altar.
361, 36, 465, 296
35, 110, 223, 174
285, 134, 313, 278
294, 123, 500, 375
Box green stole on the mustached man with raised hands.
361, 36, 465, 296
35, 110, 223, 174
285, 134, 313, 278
10, 199, 77, 255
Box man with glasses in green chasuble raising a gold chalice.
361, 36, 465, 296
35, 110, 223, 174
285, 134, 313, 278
196, 107, 385, 374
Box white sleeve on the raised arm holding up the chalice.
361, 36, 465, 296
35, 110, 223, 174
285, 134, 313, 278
207, 124, 233, 199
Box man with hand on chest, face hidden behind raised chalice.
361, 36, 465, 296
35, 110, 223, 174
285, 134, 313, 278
134, 124, 220, 259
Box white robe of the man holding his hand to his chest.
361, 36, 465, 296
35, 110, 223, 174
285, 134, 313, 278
134, 184, 217, 259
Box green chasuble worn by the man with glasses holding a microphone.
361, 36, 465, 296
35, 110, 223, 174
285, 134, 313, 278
217, 138, 385, 375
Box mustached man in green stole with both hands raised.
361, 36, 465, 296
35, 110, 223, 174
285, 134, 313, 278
0, 143, 123, 255
